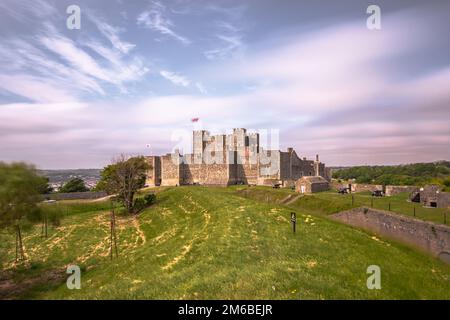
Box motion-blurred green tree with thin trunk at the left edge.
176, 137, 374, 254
0, 162, 47, 261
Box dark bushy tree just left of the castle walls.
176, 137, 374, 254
96, 155, 149, 213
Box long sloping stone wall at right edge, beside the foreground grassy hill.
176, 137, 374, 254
331, 207, 450, 264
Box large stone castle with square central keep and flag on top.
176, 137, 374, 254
146, 128, 331, 187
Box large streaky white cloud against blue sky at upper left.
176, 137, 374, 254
0, 15, 149, 102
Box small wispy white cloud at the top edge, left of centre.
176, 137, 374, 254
137, 2, 191, 45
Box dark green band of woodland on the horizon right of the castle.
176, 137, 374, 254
333, 161, 450, 185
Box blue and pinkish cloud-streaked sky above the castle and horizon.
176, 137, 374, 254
0, 0, 450, 169
